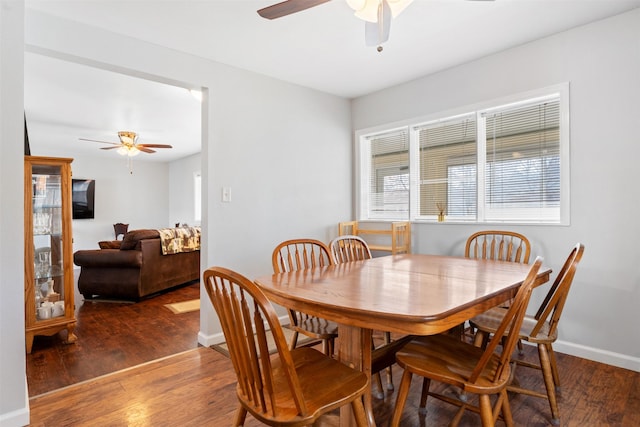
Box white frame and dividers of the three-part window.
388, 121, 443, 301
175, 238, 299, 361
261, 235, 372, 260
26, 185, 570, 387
354, 83, 571, 226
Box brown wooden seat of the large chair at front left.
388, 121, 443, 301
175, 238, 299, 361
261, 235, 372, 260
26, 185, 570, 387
241, 347, 367, 425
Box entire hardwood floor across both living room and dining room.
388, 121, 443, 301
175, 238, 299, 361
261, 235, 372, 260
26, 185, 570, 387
27, 285, 640, 427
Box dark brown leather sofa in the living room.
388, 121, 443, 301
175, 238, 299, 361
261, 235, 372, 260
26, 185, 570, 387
73, 229, 200, 301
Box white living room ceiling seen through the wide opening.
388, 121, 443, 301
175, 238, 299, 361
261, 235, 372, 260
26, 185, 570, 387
24, 53, 201, 162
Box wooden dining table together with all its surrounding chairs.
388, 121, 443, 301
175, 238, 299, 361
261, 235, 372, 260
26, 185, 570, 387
204, 230, 584, 426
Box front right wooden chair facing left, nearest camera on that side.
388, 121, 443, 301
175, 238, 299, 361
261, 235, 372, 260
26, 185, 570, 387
391, 257, 542, 427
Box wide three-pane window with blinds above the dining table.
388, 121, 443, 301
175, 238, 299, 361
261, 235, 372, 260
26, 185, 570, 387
359, 86, 569, 224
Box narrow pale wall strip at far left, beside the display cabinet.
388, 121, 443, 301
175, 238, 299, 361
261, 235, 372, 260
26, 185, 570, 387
0, 0, 29, 427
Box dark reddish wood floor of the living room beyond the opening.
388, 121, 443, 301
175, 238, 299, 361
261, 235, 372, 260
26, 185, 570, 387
26, 282, 200, 397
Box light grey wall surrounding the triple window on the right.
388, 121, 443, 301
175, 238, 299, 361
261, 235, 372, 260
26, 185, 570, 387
352, 9, 640, 371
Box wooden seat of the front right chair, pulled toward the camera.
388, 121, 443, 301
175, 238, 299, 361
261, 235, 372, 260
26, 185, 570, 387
396, 334, 510, 394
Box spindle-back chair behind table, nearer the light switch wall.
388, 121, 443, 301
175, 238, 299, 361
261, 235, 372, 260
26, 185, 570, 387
271, 239, 338, 356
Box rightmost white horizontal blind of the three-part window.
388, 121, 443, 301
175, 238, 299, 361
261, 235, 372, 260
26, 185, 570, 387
484, 97, 560, 222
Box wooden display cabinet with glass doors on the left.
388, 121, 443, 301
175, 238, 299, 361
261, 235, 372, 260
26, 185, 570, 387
24, 156, 77, 353
